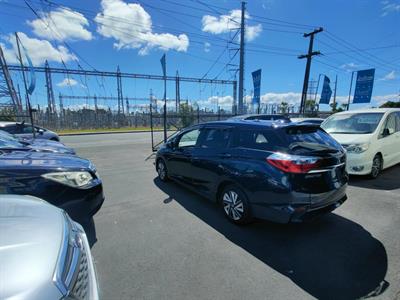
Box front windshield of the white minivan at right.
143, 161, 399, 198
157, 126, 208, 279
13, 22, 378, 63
321, 113, 383, 134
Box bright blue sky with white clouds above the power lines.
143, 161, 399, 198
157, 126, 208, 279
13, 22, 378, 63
0, 0, 400, 110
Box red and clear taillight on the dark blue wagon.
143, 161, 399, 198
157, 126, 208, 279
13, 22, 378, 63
267, 153, 321, 174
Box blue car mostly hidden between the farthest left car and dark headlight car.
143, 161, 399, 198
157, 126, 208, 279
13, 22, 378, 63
0, 130, 76, 155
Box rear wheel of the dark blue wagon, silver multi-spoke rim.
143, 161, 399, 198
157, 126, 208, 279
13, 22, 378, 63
220, 185, 253, 225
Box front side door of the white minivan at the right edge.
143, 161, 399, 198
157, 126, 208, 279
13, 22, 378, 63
379, 113, 399, 168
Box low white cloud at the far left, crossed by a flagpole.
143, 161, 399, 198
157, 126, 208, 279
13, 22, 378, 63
1, 32, 78, 66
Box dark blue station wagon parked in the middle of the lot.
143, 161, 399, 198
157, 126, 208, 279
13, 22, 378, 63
155, 120, 348, 224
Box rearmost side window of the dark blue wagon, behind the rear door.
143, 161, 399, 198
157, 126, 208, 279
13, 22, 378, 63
233, 129, 284, 151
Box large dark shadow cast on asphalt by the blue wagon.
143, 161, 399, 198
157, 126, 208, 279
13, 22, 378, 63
154, 178, 389, 299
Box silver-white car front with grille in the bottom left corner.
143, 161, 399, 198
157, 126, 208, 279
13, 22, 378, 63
0, 195, 99, 300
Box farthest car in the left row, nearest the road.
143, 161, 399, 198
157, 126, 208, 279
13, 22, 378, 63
0, 122, 60, 142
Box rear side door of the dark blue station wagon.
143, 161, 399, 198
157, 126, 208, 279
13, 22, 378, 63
192, 126, 232, 196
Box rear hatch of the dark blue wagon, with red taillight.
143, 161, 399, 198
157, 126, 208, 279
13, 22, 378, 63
267, 124, 348, 203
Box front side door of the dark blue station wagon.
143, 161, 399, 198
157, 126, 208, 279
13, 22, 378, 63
166, 127, 200, 185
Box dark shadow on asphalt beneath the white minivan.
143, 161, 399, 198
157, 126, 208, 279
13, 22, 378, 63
349, 164, 400, 190
